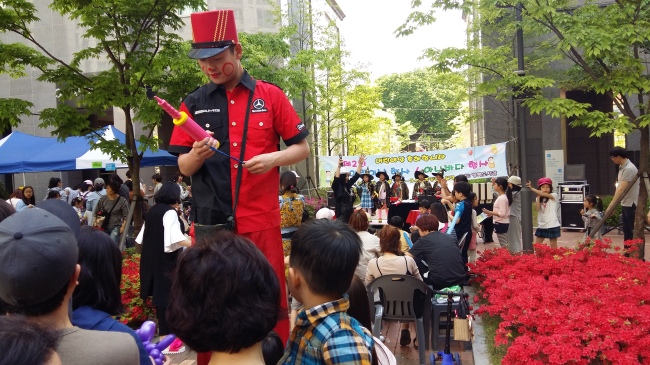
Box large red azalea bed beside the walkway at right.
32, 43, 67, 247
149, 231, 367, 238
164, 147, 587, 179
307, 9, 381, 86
472, 240, 650, 364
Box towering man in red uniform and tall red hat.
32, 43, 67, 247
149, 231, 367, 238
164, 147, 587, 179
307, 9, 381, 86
168, 10, 309, 346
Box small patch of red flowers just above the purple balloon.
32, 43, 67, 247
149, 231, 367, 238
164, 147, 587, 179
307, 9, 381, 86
120, 248, 156, 328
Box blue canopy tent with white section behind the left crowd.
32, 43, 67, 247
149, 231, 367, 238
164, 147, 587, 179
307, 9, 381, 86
0, 126, 177, 174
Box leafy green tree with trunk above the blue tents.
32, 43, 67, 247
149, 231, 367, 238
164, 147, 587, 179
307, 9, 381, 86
0, 0, 204, 191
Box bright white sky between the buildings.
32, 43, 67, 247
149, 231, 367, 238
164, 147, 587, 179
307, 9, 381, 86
337, 0, 466, 80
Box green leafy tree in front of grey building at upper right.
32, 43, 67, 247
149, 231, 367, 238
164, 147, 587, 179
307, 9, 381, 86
398, 0, 650, 246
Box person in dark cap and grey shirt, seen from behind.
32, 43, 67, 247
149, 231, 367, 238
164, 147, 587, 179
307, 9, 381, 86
0, 208, 140, 365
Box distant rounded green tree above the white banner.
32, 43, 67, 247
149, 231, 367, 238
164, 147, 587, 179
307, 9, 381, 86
377, 69, 467, 142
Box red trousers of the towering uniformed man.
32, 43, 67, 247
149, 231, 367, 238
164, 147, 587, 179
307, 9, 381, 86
196, 227, 289, 365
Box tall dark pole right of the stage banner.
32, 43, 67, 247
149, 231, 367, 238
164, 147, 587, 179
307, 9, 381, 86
515, 3, 533, 253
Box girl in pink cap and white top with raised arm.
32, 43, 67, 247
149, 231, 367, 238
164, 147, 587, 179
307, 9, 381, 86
526, 177, 560, 248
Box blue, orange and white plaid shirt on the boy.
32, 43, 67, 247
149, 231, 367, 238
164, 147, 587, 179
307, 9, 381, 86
278, 295, 374, 365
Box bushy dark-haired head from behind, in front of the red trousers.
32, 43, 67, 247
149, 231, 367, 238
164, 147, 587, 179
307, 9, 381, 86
165, 232, 278, 365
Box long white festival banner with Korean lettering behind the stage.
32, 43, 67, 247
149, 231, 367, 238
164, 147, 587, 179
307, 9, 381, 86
320, 143, 508, 186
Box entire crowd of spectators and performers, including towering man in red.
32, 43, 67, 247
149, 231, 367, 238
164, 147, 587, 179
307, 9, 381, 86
0, 2, 640, 365
